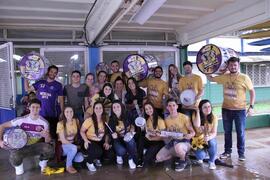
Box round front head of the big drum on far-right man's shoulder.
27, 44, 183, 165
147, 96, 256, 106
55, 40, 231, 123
196, 44, 222, 74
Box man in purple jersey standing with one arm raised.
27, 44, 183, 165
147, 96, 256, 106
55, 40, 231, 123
25, 65, 64, 139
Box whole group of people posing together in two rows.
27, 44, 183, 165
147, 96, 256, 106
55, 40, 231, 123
0, 57, 255, 175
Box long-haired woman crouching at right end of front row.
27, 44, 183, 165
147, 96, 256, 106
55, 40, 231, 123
193, 99, 218, 169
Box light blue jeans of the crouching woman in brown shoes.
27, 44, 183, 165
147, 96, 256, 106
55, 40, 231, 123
62, 144, 83, 167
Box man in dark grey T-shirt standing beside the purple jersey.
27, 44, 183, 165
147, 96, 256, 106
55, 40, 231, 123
64, 71, 89, 124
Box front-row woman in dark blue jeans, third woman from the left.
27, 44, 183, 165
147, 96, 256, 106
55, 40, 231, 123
109, 100, 137, 169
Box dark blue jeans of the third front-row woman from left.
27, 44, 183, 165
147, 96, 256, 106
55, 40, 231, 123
113, 138, 137, 160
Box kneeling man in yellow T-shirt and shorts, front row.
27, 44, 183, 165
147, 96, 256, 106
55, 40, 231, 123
156, 98, 195, 171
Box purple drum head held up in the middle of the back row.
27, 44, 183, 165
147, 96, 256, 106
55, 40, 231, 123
123, 54, 148, 81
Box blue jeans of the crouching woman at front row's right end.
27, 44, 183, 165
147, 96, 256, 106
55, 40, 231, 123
195, 138, 217, 163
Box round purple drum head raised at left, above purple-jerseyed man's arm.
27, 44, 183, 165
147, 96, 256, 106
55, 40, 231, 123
19, 52, 48, 80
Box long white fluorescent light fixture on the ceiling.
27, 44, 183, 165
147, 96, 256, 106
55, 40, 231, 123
129, 0, 166, 25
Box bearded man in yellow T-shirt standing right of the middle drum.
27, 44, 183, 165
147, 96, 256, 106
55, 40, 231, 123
140, 66, 169, 118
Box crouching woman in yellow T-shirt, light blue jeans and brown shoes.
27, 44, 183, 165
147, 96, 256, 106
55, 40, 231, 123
56, 106, 83, 174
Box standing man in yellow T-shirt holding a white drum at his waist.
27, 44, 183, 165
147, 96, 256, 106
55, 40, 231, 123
179, 61, 203, 111
